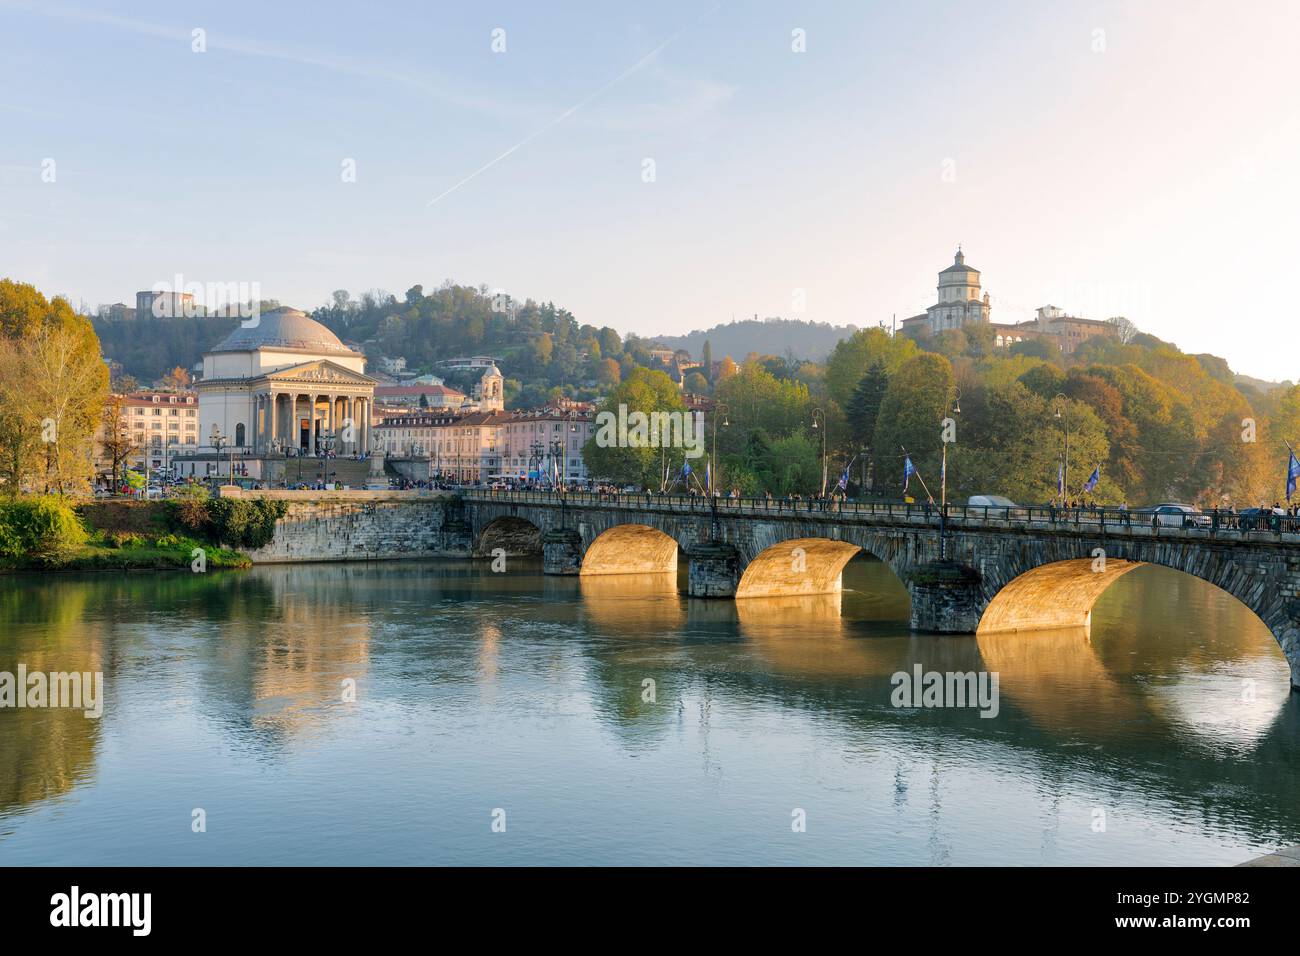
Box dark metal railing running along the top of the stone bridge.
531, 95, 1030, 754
458, 489, 1300, 537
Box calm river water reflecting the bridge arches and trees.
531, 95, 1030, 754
0, 558, 1300, 864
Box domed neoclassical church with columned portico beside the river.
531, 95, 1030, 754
195, 308, 376, 465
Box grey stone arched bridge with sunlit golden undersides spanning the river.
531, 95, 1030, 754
462, 492, 1300, 688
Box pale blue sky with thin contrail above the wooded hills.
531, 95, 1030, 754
0, 0, 1300, 380
